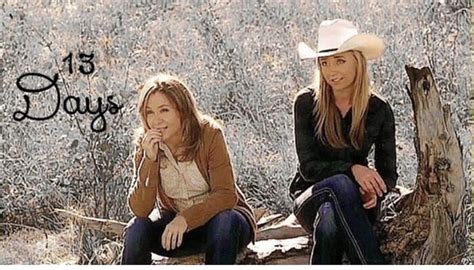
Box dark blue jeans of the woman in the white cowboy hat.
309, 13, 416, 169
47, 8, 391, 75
294, 174, 385, 264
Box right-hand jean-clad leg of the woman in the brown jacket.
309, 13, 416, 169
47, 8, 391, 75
206, 210, 252, 264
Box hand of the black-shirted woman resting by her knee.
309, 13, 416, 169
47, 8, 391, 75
351, 164, 387, 197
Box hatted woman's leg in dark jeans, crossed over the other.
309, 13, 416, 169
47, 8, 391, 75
294, 174, 385, 264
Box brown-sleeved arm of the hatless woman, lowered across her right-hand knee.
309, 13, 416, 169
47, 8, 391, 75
178, 129, 237, 231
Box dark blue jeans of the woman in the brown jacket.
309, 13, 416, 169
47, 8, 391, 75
122, 210, 251, 264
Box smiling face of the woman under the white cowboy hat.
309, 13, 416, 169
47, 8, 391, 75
319, 52, 357, 94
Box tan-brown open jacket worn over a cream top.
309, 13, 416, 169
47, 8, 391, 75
128, 121, 257, 241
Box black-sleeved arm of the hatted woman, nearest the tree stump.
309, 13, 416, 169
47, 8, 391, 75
374, 103, 398, 190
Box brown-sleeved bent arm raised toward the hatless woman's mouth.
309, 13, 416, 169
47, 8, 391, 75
128, 148, 159, 218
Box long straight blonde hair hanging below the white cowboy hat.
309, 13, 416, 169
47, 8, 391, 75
313, 51, 376, 149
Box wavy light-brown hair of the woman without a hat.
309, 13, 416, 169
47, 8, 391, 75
135, 73, 203, 160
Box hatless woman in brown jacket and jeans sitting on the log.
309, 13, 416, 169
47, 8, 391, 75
122, 74, 256, 264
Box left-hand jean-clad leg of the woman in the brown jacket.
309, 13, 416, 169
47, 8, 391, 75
122, 211, 174, 264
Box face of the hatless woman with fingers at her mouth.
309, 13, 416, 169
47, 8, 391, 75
145, 91, 183, 146
